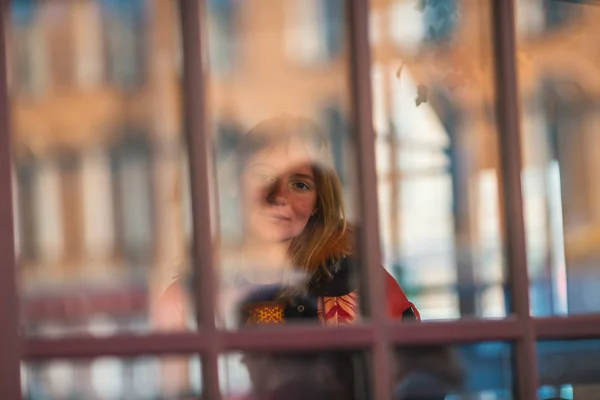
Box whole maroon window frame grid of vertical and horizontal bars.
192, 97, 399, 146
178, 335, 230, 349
0, 0, 600, 400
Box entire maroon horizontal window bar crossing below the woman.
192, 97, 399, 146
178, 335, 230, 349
23, 315, 600, 360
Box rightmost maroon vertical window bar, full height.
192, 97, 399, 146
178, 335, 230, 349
492, 0, 538, 399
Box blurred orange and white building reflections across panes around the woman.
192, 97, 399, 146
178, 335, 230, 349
7, 0, 600, 399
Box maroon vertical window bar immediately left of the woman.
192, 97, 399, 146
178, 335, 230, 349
179, 0, 221, 400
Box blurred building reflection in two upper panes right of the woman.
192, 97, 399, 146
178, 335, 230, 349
371, 0, 600, 318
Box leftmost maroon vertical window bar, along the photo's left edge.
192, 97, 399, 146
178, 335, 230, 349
0, 0, 21, 399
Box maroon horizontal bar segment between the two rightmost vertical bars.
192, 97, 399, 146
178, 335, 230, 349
389, 317, 527, 345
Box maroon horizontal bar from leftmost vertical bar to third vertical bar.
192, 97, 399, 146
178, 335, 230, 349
23, 325, 374, 360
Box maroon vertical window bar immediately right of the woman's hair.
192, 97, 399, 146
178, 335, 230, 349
348, 0, 392, 400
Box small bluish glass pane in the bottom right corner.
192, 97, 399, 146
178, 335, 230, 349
537, 339, 600, 400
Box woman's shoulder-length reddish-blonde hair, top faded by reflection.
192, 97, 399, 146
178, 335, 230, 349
238, 117, 352, 290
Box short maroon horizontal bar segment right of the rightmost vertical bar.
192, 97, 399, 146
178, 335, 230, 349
533, 315, 600, 340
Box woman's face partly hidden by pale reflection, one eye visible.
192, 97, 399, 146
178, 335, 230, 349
242, 140, 317, 242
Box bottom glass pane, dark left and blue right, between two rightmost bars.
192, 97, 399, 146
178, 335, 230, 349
393, 342, 514, 400
